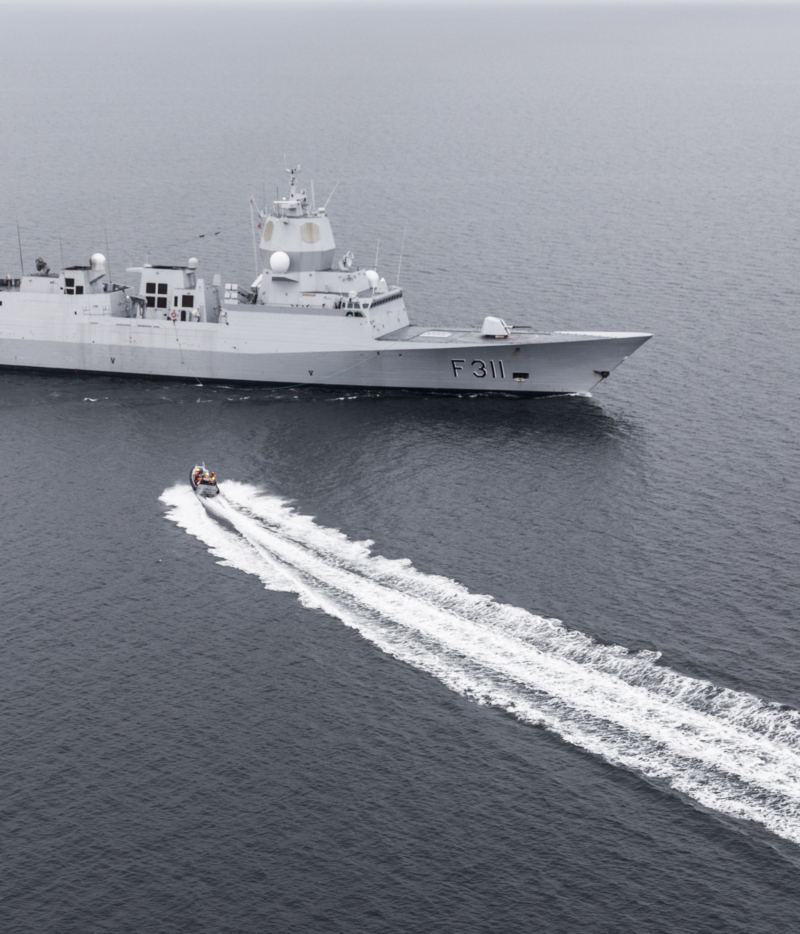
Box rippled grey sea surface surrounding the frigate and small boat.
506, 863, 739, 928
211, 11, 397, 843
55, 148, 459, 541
0, 5, 800, 934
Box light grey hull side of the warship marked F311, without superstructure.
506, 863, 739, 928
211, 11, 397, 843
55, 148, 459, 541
0, 309, 649, 395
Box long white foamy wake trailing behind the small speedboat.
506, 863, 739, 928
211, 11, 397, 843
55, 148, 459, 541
161, 481, 800, 844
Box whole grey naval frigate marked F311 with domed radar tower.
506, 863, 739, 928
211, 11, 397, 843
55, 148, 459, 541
0, 167, 651, 395
